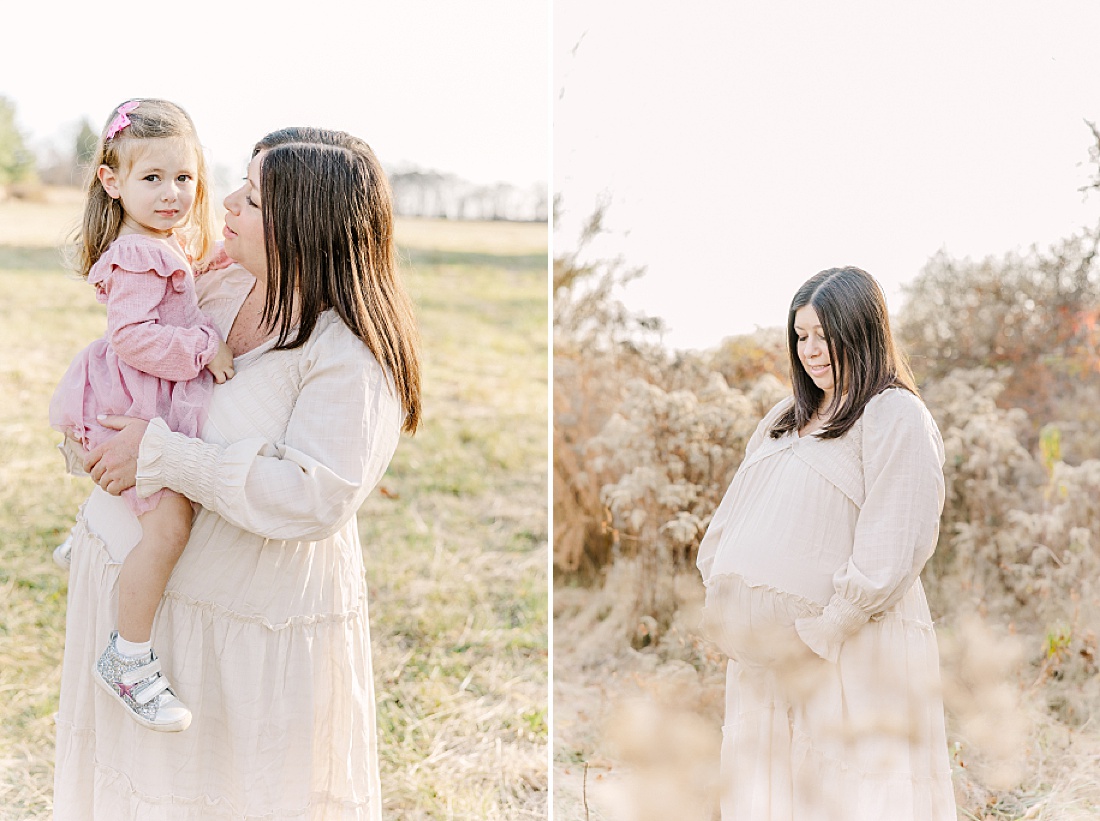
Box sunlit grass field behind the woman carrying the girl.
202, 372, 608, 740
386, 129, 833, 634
0, 193, 549, 821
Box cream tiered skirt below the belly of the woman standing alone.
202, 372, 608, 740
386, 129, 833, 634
704, 573, 956, 821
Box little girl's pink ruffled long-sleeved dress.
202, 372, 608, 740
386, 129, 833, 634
50, 234, 221, 515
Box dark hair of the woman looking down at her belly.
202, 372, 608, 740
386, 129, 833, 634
770, 267, 919, 439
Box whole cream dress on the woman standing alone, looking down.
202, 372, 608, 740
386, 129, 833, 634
699, 388, 956, 821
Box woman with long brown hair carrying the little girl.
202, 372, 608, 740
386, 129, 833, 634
54, 129, 420, 821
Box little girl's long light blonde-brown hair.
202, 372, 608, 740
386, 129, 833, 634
74, 98, 215, 277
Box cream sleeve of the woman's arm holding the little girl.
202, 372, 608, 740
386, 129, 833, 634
130, 320, 403, 541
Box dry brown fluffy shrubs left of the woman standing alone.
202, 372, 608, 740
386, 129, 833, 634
553, 208, 787, 633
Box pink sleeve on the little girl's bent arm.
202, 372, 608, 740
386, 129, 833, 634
102, 267, 221, 382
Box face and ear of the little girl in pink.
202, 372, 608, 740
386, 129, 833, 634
97, 138, 198, 237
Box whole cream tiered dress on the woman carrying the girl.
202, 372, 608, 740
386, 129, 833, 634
54, 266, 403, 821
